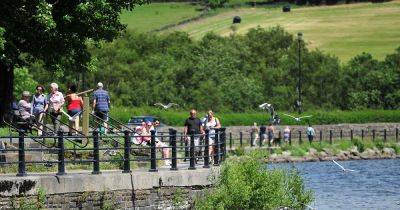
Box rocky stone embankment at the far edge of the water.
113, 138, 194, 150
267, 147, 400, 163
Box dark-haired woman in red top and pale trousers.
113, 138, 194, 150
66, 85, 83, 135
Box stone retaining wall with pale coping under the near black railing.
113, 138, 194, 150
0, 167, 219, 209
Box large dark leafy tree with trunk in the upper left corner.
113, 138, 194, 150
0, 0, 145, 124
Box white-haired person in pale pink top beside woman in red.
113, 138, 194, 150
47, 83, 65, 132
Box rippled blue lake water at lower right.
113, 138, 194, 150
272, 159, 400, 210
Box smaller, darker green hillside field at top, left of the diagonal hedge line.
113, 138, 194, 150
121, 3, 201, 32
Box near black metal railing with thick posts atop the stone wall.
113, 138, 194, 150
0, 128, 226, 176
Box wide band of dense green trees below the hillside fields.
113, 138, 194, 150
28, 27, 400, 111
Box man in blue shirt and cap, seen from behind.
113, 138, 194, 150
93, 82, 110, 133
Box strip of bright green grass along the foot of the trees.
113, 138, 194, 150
111, 107, 400, 126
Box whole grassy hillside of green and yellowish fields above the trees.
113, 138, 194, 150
122, 1, 400, 61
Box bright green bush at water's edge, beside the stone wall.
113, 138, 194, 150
196, 156, 313, 209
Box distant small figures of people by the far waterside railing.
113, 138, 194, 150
250, 122, 315, 145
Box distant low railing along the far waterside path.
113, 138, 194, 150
227, 126, 399, 149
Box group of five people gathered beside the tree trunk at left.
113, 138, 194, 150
17, 82, 110, 135
